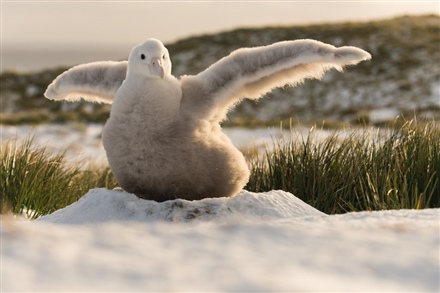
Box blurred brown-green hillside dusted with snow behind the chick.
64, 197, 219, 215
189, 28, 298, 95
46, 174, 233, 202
1, 15, 440, 126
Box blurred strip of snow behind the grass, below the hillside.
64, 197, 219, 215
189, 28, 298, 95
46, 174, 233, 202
0, 123, 330, 165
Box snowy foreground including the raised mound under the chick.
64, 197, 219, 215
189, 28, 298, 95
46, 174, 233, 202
0, 189, 440, 292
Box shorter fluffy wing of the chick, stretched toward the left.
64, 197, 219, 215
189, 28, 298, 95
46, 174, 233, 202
44, 61, 127, 104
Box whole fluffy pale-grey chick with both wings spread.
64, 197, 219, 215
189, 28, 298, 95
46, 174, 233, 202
46, 39, 371, 201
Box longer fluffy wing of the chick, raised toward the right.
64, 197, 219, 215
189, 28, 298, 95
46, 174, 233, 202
181, 40, 371, 122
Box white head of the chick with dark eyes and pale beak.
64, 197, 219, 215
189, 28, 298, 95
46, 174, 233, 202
128, 39, 171, 79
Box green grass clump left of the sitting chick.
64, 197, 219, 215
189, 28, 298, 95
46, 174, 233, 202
0, 138, 116, 219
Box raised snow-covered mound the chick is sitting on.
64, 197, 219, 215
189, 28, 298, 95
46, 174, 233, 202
37, 188, 326, 224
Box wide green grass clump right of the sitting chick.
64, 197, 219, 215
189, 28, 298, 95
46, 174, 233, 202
246, 121, 440, 214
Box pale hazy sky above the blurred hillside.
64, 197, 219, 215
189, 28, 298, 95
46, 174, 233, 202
1, 0, 440, 70
